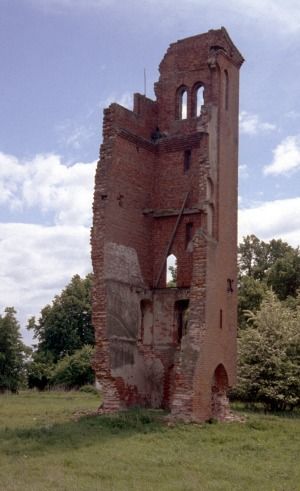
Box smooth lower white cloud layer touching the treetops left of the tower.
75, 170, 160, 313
0, 223, 91, 341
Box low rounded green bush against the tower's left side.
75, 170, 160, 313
52, 346, 95, 389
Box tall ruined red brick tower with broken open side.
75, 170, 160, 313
91, 28, 243, 421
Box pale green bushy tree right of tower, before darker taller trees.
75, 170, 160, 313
234, 292, 300, 410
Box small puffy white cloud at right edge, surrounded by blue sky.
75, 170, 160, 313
264, 134, 300, 175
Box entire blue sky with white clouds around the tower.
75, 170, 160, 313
0, 0, 300, 342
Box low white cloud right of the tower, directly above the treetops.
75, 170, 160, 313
239, 197, 300, 247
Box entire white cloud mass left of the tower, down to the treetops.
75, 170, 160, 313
0, 153, 96, 341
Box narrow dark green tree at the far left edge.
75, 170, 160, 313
0, 307, 29, 392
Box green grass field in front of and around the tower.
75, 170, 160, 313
0, 392, 300, 491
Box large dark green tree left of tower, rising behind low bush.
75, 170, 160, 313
27, 274, 94, 363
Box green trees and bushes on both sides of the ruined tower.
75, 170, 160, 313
0, 235, 300, 410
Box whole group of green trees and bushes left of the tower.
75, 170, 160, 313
0, 274, 95, 392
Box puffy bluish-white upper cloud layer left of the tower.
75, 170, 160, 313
0, 153, 96, 225
